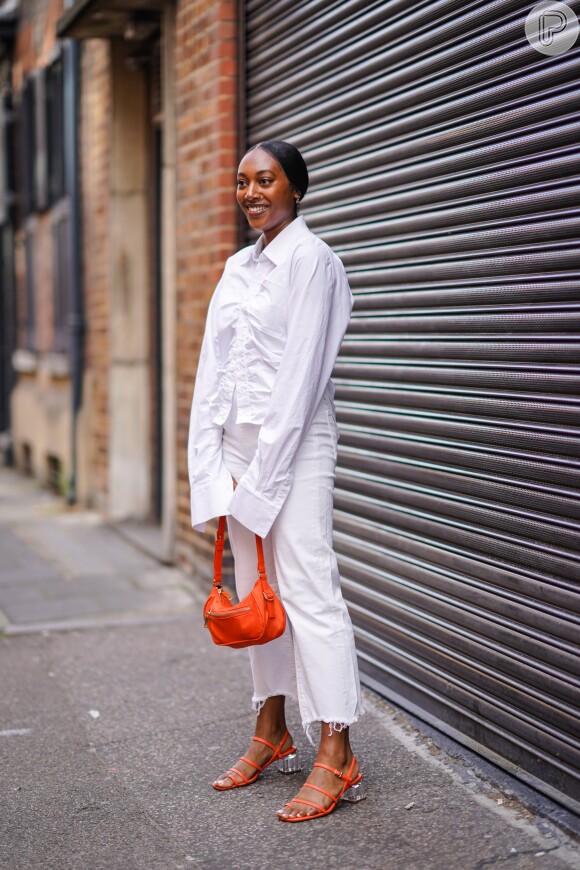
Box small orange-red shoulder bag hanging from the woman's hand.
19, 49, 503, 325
203, 517, 286, 649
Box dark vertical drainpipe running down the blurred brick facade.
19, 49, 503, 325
64, 39, 85, 504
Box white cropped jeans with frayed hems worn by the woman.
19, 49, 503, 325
223, 395, 364, 742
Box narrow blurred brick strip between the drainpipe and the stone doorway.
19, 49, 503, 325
80, 39, 111, 507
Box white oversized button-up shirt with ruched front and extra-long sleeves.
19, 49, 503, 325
188, 217, 353, 537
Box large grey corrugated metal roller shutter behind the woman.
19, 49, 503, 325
245, 0, 580, 811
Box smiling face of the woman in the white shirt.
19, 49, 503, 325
237, 148, 297, 244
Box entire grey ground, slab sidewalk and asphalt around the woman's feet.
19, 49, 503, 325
0, 470, 580, 870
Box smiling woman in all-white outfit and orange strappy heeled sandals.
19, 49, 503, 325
188, 140, 364, 822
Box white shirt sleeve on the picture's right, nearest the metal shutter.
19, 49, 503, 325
229, 246, 352, 537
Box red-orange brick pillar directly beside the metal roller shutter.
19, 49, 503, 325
175, 0, 239, 570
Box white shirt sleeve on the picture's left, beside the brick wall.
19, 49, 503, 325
187, 284, 233, 532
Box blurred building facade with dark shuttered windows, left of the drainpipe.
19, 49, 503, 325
2, 2, 81, 492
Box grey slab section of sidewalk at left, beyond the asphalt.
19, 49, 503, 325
0, 469, 193, 633
